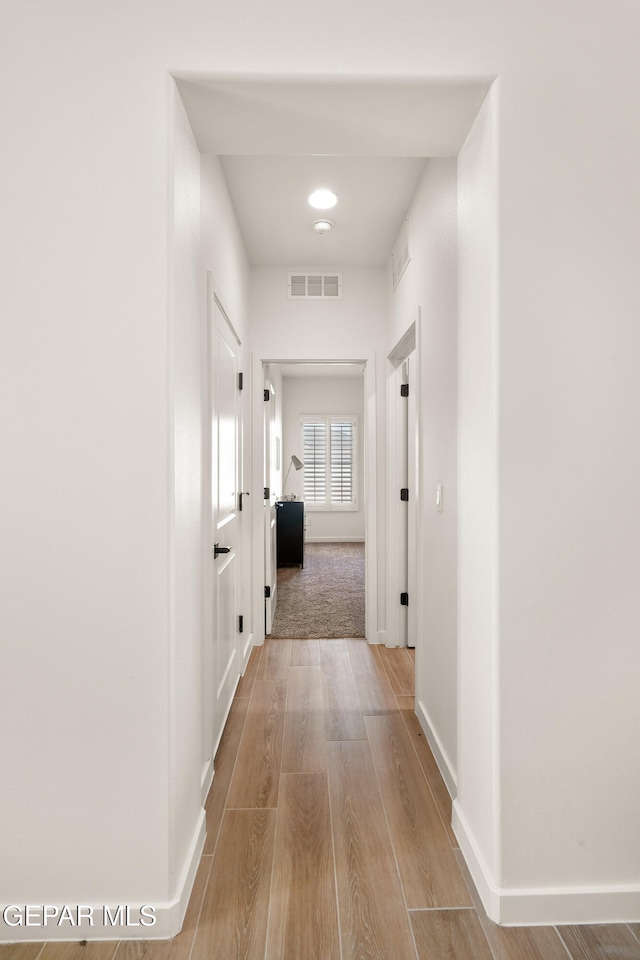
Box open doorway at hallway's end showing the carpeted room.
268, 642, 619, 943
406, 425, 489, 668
263, 360, 368, 639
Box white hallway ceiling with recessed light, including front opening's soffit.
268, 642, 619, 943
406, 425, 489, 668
177, 77, 489, 270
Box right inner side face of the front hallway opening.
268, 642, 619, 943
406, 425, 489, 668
454, 85, 501, 907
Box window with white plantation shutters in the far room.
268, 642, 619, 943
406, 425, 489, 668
302, 416, 358, 510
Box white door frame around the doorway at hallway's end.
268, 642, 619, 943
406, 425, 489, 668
252, 354, 385, 645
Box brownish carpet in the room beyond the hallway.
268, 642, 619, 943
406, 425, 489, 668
271, 543, 365, 640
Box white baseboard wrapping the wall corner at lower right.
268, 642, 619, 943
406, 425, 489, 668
452, 800, 640, 927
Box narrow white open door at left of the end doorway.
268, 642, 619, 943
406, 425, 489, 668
264, 372, 280, 635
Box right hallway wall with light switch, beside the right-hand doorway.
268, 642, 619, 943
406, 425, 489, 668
388, 158, 458, 792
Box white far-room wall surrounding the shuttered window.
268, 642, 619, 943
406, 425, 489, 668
283, 376, 365, 541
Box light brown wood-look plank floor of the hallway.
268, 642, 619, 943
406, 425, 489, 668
6, 640, 640, 960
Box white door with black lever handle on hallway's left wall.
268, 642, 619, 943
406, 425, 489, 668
209, 299, 242, 744
